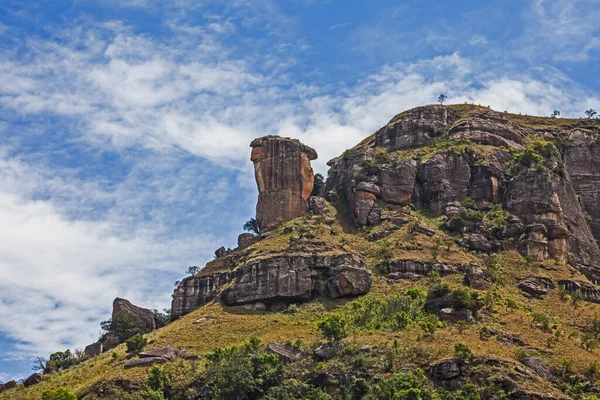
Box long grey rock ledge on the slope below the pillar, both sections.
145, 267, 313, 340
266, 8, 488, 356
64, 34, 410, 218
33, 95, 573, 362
171, 253, 371, 319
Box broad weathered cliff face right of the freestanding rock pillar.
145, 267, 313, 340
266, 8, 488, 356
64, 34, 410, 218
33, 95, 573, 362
326, 106, 600, 280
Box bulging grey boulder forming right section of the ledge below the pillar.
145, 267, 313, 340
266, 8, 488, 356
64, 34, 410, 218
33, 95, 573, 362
220, 254, 371, 305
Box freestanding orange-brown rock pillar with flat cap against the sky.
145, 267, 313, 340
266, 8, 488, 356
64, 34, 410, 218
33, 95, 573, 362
250, 136, 317, 229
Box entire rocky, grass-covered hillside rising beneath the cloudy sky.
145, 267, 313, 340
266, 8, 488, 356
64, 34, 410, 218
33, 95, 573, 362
0, 105, 600, 400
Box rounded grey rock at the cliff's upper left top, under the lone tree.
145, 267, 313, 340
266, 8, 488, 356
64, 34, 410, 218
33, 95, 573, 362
375, 106, 456, 150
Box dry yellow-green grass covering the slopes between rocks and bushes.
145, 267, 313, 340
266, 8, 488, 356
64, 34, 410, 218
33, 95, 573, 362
0, 105, 600, 400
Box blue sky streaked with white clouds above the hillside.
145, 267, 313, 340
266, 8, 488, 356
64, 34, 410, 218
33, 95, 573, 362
0, 0, 600, 381
